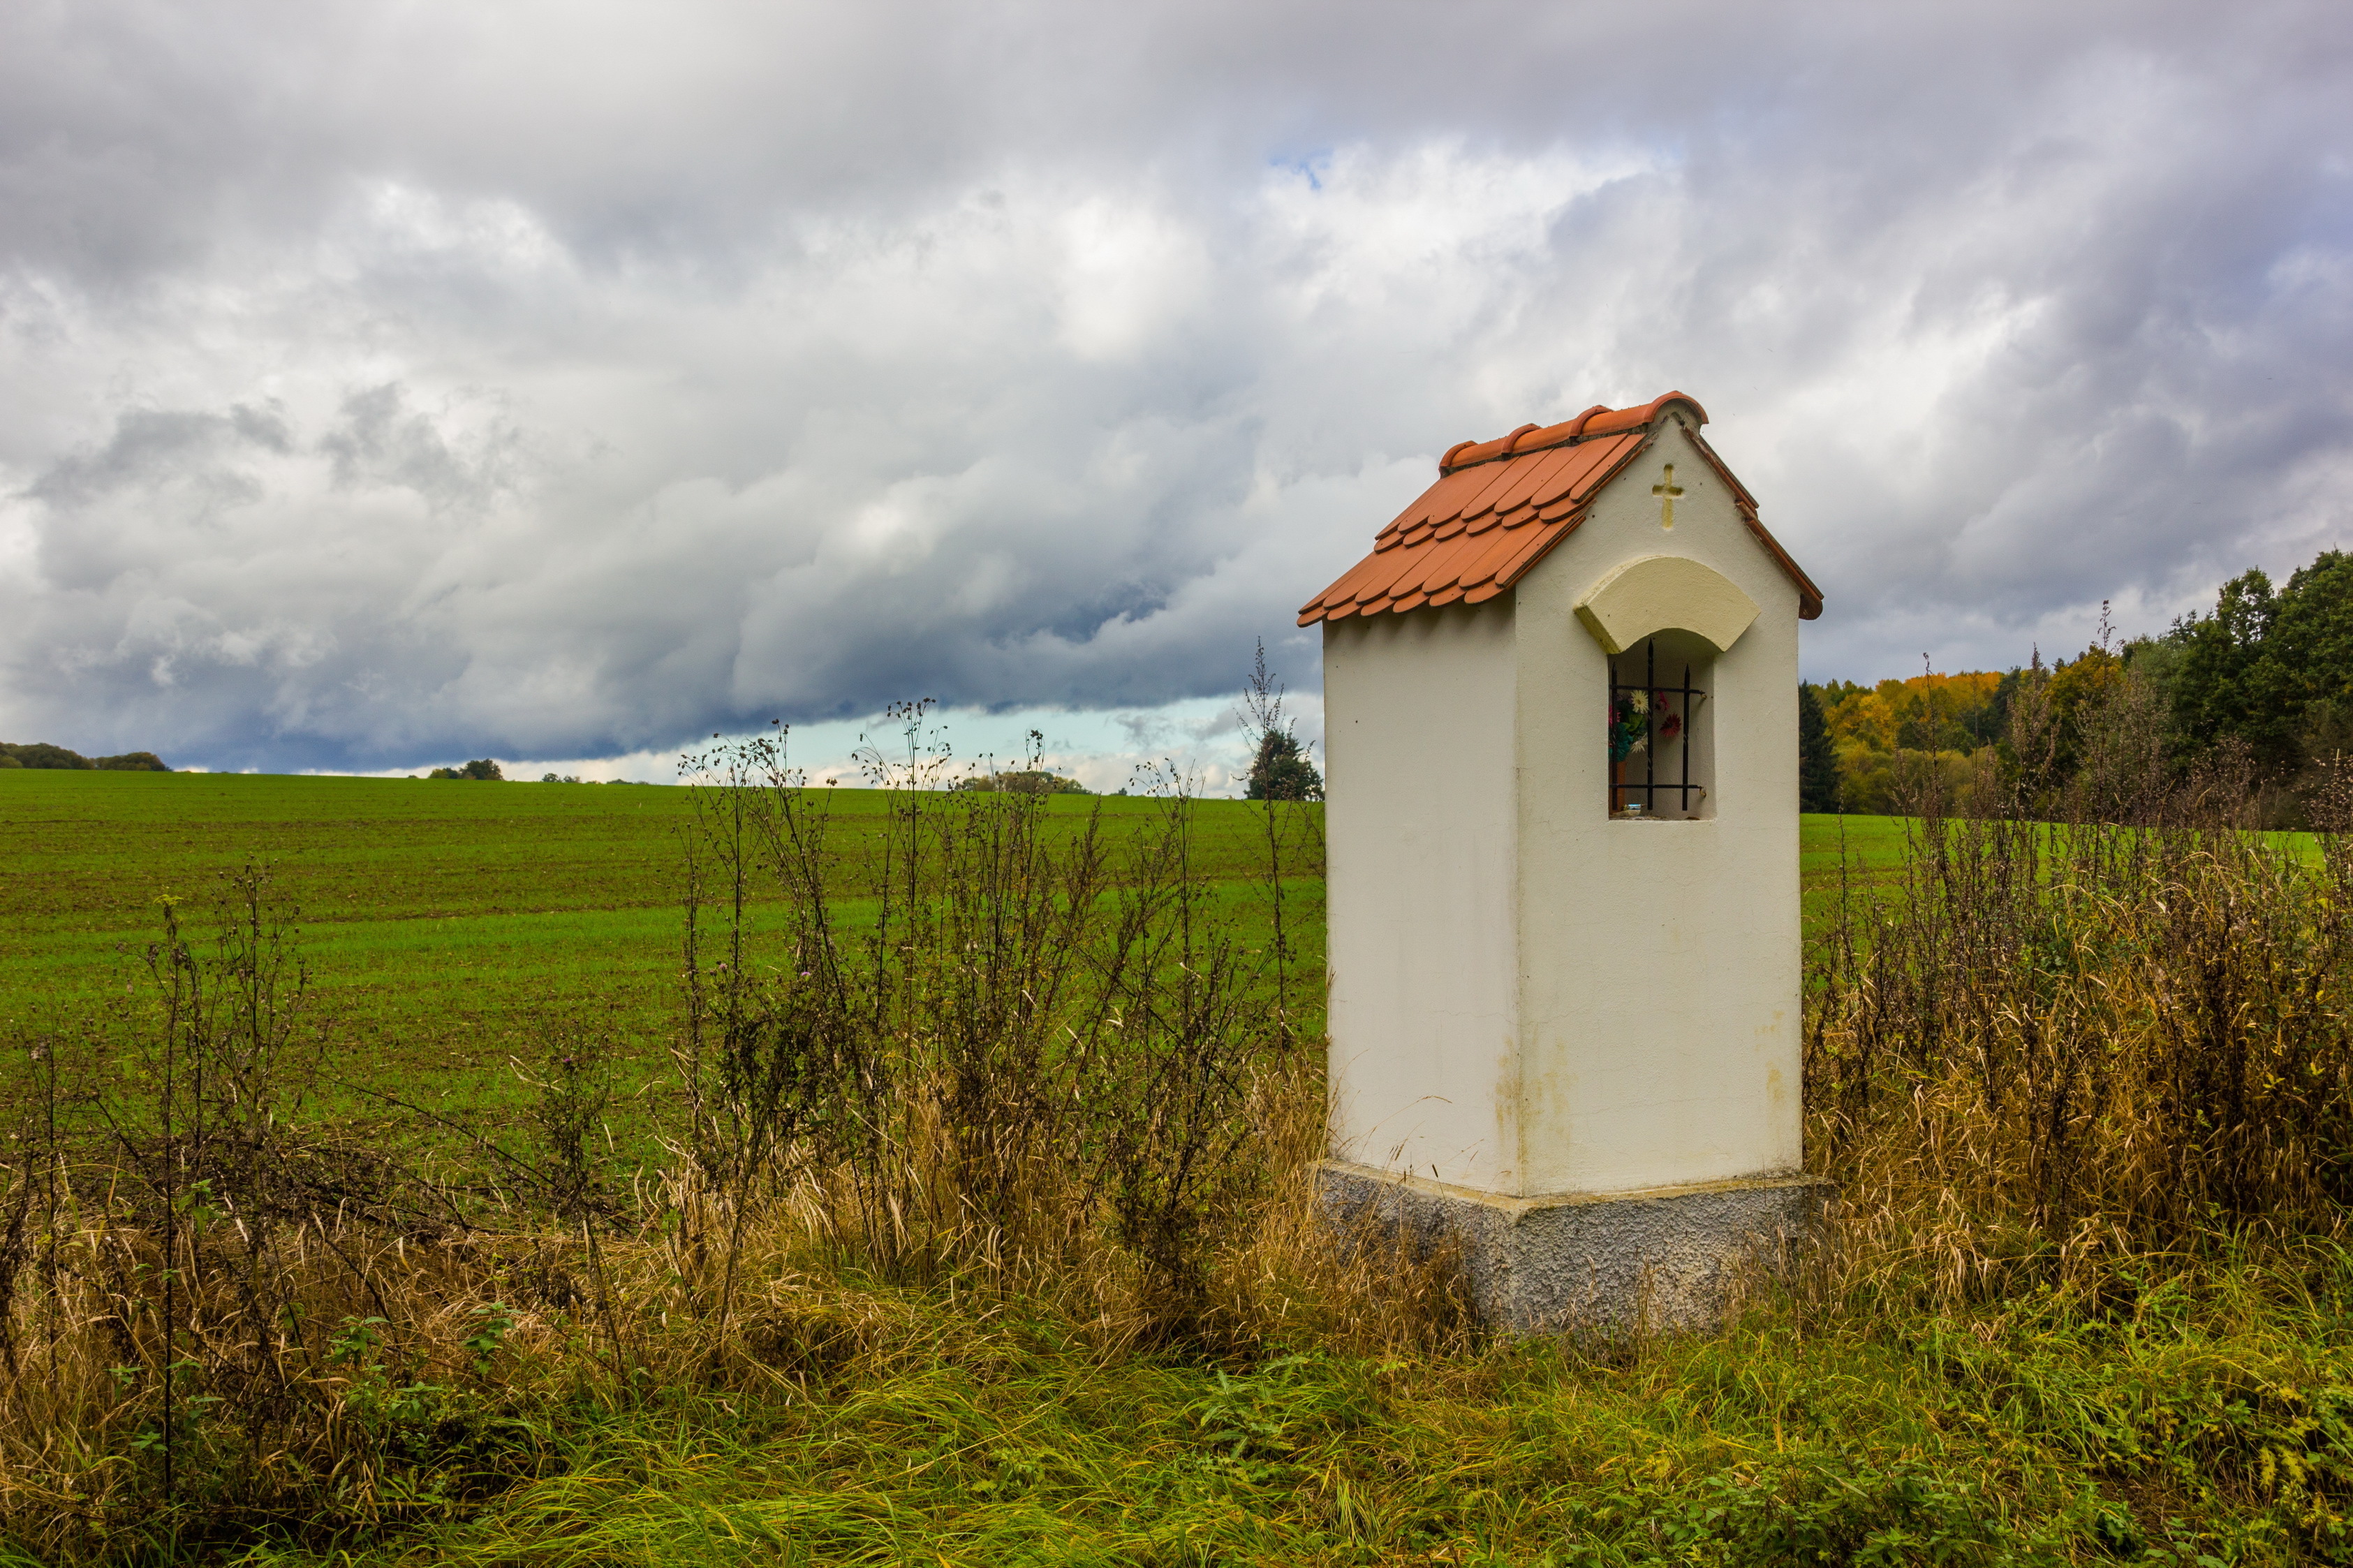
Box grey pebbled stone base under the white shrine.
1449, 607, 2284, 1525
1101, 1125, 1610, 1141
1315, 1161, 1828, 1335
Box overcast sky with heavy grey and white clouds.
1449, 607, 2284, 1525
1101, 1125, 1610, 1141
0, 0, 2353, 782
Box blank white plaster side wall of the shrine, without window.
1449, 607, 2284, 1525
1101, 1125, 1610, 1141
1325, 596, 1524, 1191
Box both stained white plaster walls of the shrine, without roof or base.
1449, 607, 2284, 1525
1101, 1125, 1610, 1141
1325, 412, 1800, 1196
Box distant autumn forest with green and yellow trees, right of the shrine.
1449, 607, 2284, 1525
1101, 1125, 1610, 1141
1798, 551, 2353, 827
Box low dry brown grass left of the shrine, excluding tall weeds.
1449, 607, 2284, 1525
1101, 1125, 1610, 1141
0, 1067, 1468, 1561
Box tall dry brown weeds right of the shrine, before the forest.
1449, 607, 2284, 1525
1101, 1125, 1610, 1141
1807, 664, 2353, 1300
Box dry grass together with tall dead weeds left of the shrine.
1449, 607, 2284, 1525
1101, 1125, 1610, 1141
0, 711, 1468, 1561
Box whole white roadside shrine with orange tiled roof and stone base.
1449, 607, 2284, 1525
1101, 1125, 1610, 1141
1299, 393, 1821, 1330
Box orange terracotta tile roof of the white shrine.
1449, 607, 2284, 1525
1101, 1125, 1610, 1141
1299, 393, 1821, 626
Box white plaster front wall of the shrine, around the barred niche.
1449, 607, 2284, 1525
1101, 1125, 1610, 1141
1505, 426, 1802, 1196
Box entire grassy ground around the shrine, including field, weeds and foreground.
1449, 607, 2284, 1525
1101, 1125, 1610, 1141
0, 770, 2353, 1568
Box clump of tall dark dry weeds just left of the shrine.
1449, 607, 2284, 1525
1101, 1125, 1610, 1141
678, 704, 1290, 1340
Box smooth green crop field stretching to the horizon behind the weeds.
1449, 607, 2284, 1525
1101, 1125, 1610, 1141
0, 770, 1903, 1079
